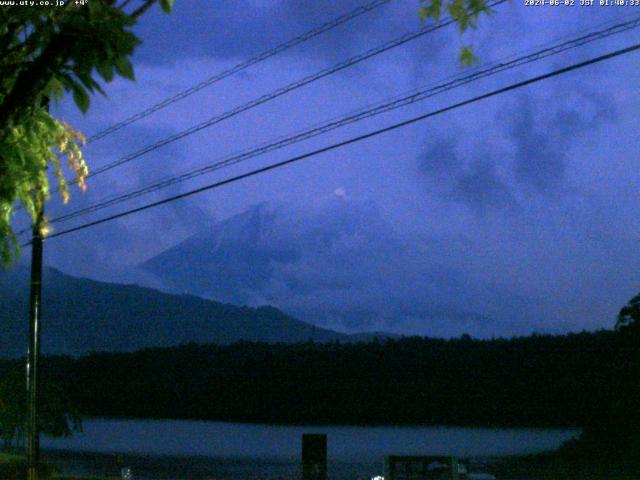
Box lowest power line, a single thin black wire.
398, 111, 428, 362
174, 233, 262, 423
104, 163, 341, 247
22, 43, 640, 247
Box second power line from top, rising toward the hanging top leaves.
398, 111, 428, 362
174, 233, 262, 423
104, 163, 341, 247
82, 0, 507, 182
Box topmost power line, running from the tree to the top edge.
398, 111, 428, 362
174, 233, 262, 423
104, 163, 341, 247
87, 0, 391, 143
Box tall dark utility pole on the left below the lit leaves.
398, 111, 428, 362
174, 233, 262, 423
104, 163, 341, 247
26, 98, 49, 480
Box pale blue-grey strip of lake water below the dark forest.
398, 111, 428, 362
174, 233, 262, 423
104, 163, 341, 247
42, 418, 578, 462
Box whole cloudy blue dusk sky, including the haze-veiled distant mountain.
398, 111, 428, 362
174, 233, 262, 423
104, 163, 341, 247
12, 0, 640, 337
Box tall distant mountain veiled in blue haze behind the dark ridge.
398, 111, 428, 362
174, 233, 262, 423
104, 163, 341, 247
139, 195, 530, 337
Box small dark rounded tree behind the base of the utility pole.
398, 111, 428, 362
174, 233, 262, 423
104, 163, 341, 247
0, 369, 82, 449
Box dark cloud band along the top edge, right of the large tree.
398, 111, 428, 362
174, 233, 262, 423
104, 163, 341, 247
136, 0, 408, 64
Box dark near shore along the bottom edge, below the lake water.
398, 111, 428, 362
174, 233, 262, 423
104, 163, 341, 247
42, 449, 635, 480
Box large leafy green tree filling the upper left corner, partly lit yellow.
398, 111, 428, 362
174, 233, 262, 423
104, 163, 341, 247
0, 0, 173, 265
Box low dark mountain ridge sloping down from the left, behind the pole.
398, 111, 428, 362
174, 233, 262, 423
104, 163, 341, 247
0, 267, 350, 357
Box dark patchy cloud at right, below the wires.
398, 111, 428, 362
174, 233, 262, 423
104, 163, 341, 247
418, 87, 616, 214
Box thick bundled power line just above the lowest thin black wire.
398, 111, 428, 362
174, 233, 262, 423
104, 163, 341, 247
40, 16, 640, 230
